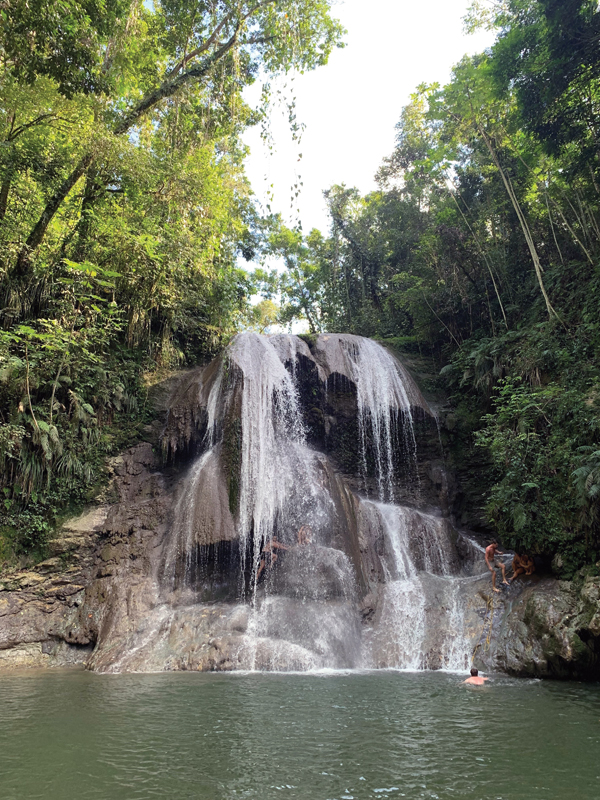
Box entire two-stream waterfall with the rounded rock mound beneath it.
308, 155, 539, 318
94, 333, 478, 671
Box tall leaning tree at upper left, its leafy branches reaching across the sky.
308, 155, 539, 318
10, 0, 342, 282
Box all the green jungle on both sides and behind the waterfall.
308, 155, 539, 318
0, 0, 600, 577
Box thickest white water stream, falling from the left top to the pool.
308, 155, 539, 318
230, 334, 366, 669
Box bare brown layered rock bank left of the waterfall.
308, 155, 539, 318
0, 443, 168, 666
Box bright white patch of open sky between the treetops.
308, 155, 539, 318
244, 0, 493, 233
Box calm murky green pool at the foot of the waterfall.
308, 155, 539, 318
0, 671, 600, 800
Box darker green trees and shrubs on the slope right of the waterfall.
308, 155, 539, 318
258, 0, 600, 575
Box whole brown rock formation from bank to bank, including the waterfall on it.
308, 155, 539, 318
0, 334, 600, 678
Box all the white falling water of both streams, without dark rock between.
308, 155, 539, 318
134, 333, 476, 670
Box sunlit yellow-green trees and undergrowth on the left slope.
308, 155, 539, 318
0, 0, 342, 562
